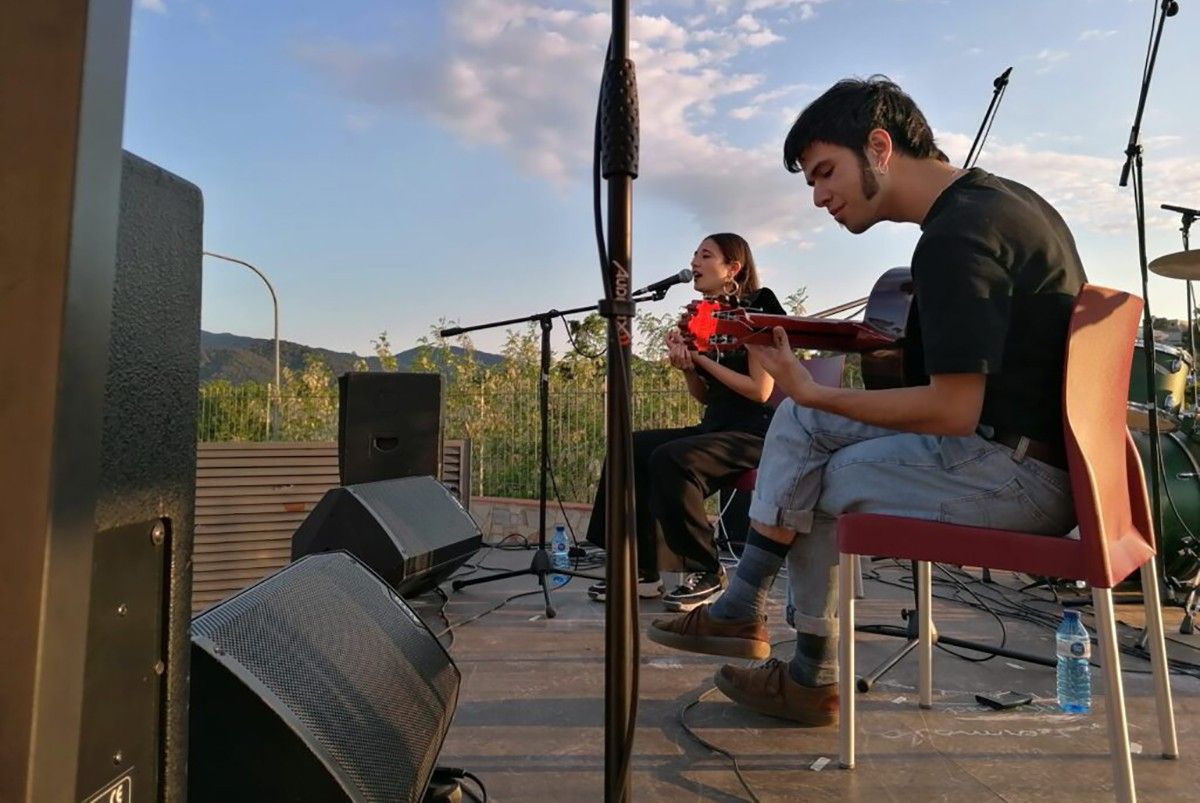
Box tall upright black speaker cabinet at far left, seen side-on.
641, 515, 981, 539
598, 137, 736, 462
77, 154, 204, 803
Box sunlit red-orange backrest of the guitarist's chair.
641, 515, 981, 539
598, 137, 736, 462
1063, 284, 1154, 588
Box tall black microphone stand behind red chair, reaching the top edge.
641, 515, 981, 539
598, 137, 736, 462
1120, 0, 1180, 645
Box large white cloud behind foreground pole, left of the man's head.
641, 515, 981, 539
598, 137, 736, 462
298, 0, 820, 245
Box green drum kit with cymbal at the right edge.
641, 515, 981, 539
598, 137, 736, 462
1127, 214, 1200, 633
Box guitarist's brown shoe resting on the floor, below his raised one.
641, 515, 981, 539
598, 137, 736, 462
713, 658, 838, 727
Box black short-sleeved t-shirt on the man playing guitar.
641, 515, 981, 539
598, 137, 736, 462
906, 168, 1087, 443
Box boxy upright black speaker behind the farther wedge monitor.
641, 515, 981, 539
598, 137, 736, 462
337, 372, 442, 485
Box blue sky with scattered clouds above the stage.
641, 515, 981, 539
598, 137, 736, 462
125, 0, 1200, 353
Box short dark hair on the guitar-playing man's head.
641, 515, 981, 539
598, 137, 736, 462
784, 76, 948, 173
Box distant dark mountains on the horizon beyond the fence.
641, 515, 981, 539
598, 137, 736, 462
200, 330, 504, 385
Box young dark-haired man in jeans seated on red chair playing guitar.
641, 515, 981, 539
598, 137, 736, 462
648, 76, 1085, 725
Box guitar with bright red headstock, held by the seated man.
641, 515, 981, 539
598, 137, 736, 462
679, 268, 912, 389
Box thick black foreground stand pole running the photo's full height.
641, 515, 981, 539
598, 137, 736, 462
593, 0, 641, 803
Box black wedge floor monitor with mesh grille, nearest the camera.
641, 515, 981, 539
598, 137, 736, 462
188, 552, 461, 803
